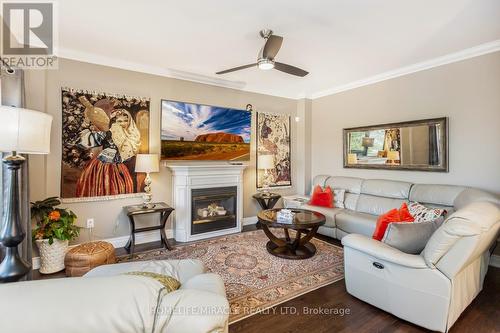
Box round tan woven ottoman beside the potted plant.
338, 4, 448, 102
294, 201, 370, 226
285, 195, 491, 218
64, 241, 116, 276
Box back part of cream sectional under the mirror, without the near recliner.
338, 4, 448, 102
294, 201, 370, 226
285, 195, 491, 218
301, 175, 500, 239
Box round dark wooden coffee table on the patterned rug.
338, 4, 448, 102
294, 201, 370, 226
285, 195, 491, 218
257, 208, 325, 259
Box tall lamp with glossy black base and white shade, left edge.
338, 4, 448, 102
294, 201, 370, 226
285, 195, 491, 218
0, 106, 52, 282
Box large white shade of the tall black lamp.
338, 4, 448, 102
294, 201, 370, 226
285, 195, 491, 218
0, 105, 52, 154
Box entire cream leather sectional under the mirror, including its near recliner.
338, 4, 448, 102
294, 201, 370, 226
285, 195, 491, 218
298, 176, 500, 332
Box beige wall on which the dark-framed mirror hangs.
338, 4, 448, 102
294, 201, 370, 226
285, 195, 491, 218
311, 52, 500, 193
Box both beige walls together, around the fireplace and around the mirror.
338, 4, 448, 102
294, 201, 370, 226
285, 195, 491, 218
26, 52, 500, 241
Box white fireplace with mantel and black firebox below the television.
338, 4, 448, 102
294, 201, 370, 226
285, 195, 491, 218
167, 162, 246, 242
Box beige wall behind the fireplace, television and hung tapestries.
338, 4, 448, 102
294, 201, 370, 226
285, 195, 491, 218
26, 59, 302, 241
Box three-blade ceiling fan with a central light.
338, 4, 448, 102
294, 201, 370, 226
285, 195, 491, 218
215, 29, 309, 77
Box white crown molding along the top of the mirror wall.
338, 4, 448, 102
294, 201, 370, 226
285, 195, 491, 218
309, 39, 500, 99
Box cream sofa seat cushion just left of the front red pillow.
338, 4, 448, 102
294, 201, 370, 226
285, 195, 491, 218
335, 210, 377, 237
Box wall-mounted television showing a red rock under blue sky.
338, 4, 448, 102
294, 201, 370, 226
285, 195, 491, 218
161, 100, 252, 161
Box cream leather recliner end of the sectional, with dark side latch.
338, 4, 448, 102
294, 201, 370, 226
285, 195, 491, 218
342, 201, 500, 332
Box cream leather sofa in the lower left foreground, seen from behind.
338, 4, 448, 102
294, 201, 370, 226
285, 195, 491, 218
0, 260, 229, 333
